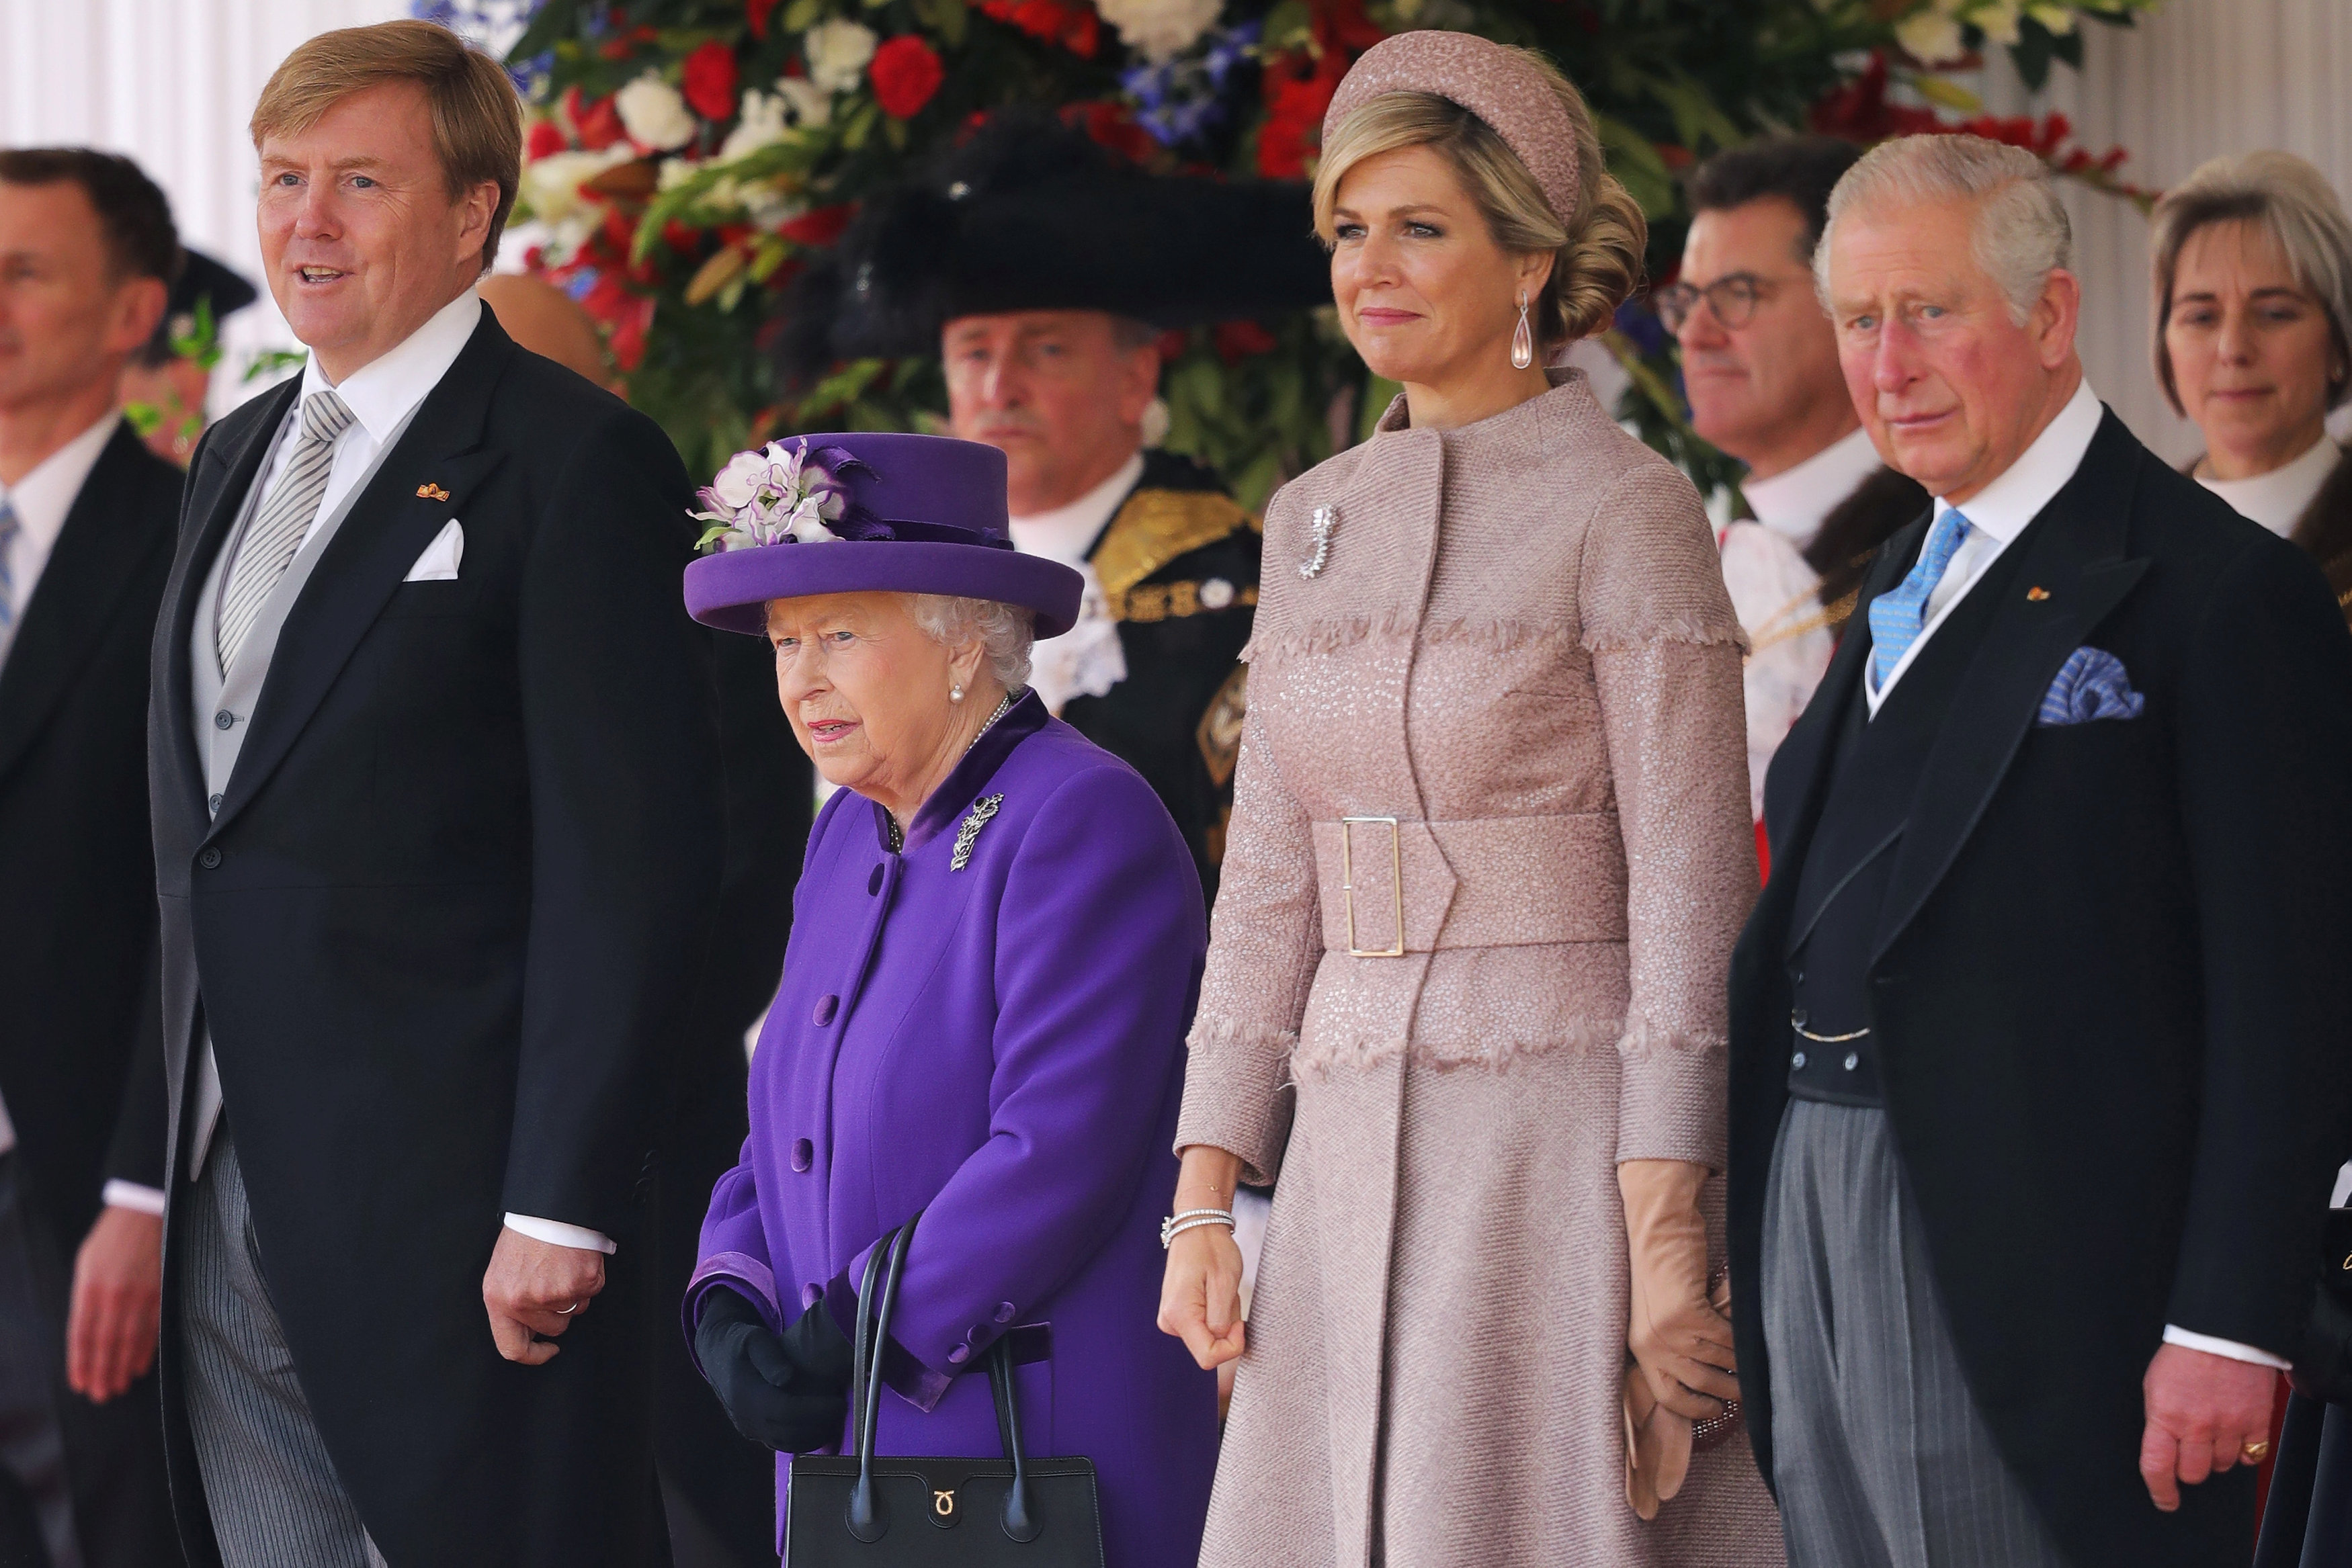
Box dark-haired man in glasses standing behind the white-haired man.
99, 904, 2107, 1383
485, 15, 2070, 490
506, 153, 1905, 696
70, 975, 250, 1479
1658, 136, 1927, 848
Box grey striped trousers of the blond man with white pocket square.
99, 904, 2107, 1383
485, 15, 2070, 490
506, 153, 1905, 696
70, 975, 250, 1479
177, 1142, 386, 1568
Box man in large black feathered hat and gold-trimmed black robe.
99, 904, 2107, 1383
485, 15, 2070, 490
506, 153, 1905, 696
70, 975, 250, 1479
786, 113, 1331, 903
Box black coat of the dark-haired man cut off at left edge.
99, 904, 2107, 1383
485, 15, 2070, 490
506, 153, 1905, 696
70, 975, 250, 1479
0, 425, 181, 1568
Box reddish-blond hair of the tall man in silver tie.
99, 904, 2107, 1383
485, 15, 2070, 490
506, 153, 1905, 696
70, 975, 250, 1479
252, 21, 522, 273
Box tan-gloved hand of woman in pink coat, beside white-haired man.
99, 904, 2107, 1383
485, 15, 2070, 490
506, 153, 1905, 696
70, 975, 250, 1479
1618, 1159, 1740, 1420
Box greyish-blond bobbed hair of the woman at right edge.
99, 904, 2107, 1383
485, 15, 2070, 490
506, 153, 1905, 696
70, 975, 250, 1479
2148, 153, 2352, 414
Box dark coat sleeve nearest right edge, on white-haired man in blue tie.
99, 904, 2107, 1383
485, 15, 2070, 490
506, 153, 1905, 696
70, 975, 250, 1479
2169, 538, 2352, 1356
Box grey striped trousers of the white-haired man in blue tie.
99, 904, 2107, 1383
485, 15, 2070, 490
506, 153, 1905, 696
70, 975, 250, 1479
1762, 1100, 2068, 1568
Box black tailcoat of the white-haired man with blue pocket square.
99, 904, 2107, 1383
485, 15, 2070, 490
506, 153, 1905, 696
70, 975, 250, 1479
1731, 414, 2352, 1566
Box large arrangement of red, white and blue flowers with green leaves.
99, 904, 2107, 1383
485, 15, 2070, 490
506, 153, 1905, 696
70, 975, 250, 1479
421, 0, 2154, 503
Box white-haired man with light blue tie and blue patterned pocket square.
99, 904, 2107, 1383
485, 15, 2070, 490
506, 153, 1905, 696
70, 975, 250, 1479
1729, 136, 2352, 1568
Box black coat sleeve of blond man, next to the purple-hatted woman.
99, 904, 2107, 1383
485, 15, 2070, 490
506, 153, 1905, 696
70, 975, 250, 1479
506, 406, 724, 1234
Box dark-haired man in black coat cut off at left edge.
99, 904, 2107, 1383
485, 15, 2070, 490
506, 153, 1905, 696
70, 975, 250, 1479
0, 148, 181, 1568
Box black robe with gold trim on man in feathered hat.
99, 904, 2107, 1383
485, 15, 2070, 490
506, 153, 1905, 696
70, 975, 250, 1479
1061, 451, 1265, 903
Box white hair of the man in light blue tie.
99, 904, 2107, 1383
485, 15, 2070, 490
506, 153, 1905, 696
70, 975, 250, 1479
1814, 134, 2074, 326
